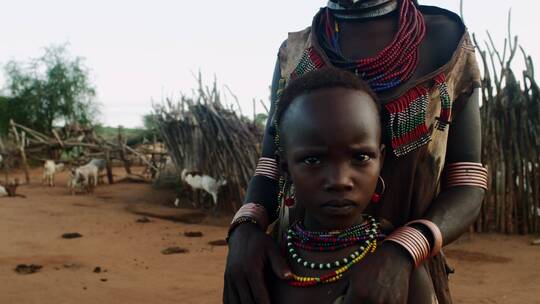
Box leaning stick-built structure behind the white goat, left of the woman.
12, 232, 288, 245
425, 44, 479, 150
155, 80, 262, 210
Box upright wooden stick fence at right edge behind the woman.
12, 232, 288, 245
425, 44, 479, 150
474, 19, 540, 233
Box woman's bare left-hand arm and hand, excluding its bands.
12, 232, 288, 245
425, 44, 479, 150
223, 48, 291, 304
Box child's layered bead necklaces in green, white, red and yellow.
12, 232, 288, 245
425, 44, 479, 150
286, 216, 383, 287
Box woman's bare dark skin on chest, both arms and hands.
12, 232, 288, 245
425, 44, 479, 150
223, 5, 484, 304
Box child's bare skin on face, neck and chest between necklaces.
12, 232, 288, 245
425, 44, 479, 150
268, 88, 434, 303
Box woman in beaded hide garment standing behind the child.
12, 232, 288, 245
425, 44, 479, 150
224, 0, 487, 303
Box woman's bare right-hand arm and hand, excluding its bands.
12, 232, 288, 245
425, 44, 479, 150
345, 89, 484, 304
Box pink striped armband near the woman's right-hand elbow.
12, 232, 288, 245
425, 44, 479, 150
442, 162, 488, 190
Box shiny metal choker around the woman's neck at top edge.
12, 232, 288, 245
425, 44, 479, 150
328, 0, 399, 20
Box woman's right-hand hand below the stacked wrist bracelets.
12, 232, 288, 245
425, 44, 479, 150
344, 242, 414, 304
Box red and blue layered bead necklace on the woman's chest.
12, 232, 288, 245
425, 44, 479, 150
316, 0, 426, 92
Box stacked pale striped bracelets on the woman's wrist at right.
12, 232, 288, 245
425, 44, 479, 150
384, 220, 442, 267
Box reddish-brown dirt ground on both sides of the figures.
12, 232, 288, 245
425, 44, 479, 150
0, 170, 540, 304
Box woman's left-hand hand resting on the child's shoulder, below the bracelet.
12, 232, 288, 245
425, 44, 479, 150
223, 224, 292, 304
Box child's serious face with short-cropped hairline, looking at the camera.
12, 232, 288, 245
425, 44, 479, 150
280, 88, 384, 230
